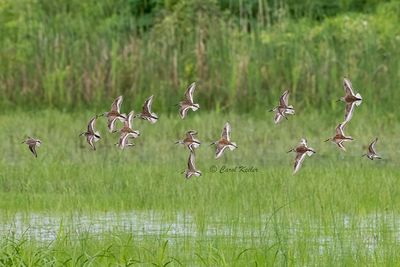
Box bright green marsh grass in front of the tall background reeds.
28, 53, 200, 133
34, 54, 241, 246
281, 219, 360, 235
0, 111, 400, 266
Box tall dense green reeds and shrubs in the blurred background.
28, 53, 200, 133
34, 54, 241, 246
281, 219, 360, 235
0, 0, 400, 112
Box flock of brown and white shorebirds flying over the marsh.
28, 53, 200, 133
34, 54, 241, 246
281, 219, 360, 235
22, 78, 381, 178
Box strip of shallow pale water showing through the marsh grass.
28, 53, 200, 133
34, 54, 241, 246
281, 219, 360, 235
0, 211, 400, 254
